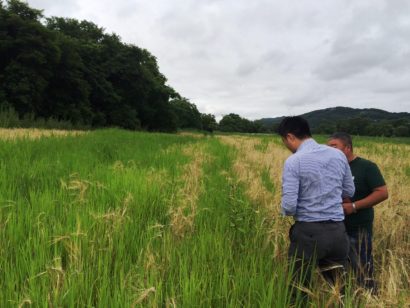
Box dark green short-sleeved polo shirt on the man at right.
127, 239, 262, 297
345, 157, 386, 234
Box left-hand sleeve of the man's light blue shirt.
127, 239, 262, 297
282, 159, 300, 216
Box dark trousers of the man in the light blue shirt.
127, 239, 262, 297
288, 221, 349, 294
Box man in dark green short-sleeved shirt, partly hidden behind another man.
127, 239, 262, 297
328, 133, 388, 291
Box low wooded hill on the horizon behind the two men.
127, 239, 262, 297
258, 107, 410, 129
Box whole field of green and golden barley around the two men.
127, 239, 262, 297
0, 129, 410, 307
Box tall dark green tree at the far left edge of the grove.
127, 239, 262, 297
0, 0, 60, 116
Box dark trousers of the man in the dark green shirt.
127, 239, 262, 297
349, 229, 376, 292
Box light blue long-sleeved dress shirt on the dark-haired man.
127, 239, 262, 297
282, 138, 355, 222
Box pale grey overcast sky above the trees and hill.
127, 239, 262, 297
28, 0, 410, 119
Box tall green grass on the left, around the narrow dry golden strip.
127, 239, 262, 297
0, 130, 298, 307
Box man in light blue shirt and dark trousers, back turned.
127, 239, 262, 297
278, 117, 354, 300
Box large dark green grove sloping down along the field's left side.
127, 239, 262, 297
0, 0, 216, 131
